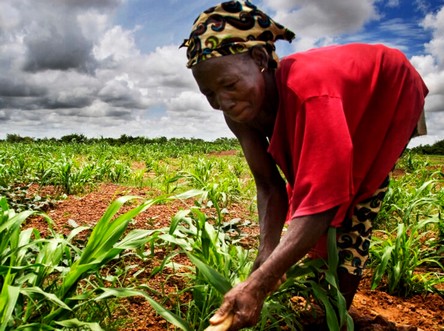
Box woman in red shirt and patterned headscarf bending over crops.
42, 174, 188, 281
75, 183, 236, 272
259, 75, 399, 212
183, 1, 428, 330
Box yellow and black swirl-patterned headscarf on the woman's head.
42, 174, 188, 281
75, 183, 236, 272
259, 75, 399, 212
181, 1, 295, 68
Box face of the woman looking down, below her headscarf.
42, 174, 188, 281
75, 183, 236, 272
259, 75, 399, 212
192, 53, 265, 123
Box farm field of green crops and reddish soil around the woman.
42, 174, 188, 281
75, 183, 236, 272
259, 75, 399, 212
0, 136, 444, 331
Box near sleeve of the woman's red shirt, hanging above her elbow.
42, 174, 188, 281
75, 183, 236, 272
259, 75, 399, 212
289, 96, 353, 218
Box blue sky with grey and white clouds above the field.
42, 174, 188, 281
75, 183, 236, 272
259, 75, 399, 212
0, 0, 444, 146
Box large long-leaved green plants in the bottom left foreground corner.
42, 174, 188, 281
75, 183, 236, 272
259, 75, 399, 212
0, 197, 191, 331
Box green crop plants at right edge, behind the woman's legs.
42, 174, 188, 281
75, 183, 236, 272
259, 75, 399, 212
370, 152, 444, 296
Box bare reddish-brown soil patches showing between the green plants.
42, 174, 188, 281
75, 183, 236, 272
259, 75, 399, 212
27, 184, 444, 331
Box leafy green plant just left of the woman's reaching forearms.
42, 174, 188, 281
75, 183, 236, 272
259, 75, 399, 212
153, 208, 252, 330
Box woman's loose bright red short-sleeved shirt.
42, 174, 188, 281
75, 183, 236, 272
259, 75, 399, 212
269, 44, 428, 227
